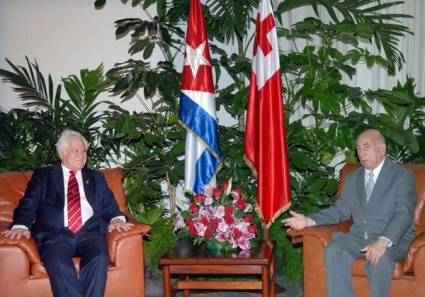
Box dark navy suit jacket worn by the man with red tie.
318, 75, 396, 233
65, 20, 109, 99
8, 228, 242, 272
12, 164, 123, 243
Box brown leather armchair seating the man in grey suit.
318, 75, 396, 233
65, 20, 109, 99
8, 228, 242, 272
288, 165, 425, 297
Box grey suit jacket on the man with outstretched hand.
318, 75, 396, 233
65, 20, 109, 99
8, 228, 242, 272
310, 159, 416, 250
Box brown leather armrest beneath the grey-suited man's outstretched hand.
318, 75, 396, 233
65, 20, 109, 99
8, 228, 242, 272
288, 222, 351, 246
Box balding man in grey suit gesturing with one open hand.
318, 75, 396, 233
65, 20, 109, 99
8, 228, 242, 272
282, 129, 416, 297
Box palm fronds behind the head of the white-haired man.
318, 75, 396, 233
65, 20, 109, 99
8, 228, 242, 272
0, 58, 119, 171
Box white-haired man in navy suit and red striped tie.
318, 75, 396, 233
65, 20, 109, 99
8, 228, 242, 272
3, 130, 133, 297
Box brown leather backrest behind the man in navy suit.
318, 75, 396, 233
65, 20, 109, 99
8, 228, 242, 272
0, 168, 127, 226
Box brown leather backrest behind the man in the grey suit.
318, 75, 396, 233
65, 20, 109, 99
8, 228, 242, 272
337, 164, 425, 234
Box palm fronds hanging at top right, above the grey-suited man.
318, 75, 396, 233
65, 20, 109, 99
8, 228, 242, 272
276, 0, 411, 74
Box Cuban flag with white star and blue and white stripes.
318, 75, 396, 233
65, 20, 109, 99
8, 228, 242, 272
179, 0, 222, 193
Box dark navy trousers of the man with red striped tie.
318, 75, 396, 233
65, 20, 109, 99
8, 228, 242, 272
39, 229, 109, 297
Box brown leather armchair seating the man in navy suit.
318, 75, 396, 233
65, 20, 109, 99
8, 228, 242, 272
0, 168, 150, 297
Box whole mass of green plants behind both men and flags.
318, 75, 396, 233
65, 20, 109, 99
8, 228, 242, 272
0, 0, 425, 279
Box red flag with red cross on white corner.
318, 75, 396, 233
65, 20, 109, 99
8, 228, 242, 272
244, 0, 291, 228
